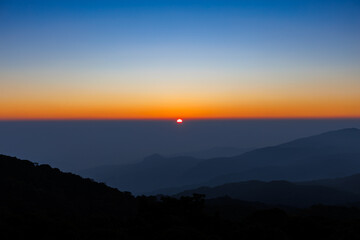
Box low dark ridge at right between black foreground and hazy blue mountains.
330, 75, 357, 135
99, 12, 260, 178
175, 181, 360, 207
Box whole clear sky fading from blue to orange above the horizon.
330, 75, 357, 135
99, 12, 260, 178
0, 0, 360, 119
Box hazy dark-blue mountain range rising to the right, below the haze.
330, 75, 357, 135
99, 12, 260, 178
79, 128, 360, 193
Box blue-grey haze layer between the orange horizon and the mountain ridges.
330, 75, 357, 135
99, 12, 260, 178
0, 119, 360, 171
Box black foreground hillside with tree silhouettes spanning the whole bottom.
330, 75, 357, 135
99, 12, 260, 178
0, 155, 360, 240
